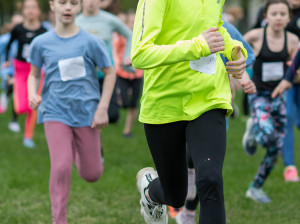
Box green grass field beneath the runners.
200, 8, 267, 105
0, 92, 300, 224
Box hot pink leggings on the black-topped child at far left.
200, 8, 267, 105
13, 60, 43, 139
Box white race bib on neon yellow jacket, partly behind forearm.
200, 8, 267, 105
190, 54, 217, 75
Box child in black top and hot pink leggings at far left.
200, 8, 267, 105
3, 0, 47, 148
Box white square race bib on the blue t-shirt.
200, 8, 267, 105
58, 56, 86, 81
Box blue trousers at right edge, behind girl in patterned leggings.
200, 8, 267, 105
282, 84, 300, 166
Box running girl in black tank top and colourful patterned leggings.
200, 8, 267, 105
243, 0, 299, 203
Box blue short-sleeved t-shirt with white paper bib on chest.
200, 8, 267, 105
29, 30, 111, 127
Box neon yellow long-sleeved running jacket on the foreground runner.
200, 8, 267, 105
131, 0, 247, 124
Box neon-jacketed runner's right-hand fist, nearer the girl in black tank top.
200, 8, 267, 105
226, 46, 246, 79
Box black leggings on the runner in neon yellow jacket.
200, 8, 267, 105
145, 109, 226, 224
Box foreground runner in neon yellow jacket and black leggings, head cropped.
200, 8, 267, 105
131, 0, 247, 224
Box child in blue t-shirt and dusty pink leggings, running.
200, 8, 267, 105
28, 0, 116, 224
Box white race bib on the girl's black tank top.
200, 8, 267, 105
262, 62, 284, 82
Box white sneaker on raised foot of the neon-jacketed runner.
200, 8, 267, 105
136, 167, 168, 224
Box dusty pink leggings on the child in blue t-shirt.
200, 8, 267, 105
44, 121, 103, 224
